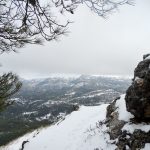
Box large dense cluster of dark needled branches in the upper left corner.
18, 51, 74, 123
0, 0, 69, 52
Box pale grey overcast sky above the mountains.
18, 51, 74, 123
0, 0, 150, 78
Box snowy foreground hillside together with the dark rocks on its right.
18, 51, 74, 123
2, 54, 150, 150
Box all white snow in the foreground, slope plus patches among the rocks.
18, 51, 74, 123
1, 95, 150, 150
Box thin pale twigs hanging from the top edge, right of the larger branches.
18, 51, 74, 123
53, 0, 134, 17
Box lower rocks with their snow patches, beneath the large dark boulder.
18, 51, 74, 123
105, 95, 150, 150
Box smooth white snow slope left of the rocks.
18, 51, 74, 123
2, 104, 116, 150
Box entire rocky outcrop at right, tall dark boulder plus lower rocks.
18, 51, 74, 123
105, 54, 150, 150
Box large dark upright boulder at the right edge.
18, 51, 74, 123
125, 54, 150, 121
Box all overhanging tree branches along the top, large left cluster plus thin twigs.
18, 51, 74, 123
0, 0, 134, 53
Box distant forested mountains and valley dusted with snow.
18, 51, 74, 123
0, 75, 131, 145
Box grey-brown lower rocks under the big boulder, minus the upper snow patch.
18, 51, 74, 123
105, 98, 150, 150
